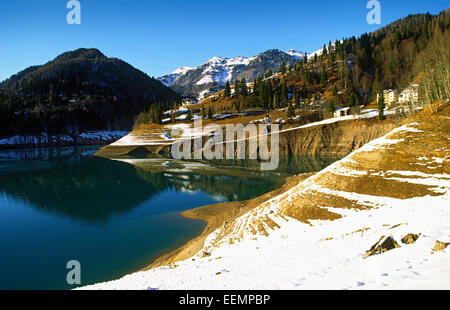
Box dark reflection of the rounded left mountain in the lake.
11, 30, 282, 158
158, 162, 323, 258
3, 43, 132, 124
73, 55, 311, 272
0, 157, 162, 222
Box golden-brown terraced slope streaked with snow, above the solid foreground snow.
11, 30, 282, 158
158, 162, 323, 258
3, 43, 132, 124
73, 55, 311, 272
202, 104, 450, 247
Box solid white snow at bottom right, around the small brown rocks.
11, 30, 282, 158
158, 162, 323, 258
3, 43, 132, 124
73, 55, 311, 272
81, 195, 450, 289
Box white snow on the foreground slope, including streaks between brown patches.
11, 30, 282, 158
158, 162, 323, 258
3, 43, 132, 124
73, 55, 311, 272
82, 123, 450, 290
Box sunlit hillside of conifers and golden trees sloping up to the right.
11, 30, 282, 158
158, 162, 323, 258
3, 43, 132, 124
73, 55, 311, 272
199, 10, 450, 116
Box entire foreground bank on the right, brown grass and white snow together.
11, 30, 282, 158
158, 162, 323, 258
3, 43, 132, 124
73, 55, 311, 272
81, 104, 450, 289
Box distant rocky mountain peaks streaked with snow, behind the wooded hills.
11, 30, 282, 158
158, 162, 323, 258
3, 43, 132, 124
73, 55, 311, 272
158, 49, 305, 98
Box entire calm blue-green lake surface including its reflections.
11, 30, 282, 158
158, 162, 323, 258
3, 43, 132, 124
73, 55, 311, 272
0, 147, 337, 289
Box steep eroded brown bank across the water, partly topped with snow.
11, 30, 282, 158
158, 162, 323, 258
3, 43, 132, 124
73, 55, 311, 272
97, 112, 400, 157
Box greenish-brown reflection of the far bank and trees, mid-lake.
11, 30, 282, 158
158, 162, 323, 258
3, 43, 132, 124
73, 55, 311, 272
133, 156, 336, 201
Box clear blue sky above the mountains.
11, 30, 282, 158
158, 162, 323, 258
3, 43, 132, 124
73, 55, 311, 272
0, 0, 449, 81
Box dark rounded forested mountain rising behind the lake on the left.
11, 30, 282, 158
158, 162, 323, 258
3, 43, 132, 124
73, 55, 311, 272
0, 48, 180, 137
